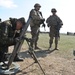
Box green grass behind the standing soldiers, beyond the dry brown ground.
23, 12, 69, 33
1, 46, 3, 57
25, 33, 75, 59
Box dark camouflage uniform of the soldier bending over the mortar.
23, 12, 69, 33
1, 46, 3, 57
0, 19, 25, 62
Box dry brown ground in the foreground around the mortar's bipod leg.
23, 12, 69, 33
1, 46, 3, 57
11, 51, 75, 75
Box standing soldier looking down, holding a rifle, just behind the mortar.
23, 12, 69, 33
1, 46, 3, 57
29, 3, 45, 49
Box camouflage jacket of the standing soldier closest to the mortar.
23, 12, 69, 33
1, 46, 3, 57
29, 9, 43, 26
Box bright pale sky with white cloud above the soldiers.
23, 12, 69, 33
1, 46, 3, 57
0, 0, 75, 33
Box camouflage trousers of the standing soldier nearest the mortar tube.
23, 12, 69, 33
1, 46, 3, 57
31, 26, 40, 47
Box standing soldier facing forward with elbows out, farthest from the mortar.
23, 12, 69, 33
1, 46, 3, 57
46, 8, 63, 50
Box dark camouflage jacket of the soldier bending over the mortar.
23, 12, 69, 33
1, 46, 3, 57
0, 21, 19, 46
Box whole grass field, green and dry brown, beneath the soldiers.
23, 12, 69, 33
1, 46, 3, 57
17, 33, 75, 75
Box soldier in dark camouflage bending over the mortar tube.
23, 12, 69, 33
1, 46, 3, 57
0, 18, 24, 62
